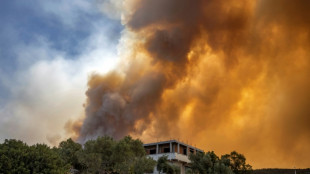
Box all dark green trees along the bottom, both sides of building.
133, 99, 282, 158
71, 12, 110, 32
0, 136, 252, 174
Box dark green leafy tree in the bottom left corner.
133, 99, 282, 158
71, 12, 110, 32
0, 139, 69, 174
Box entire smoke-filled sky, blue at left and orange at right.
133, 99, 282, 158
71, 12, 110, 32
0, 0, 310, 168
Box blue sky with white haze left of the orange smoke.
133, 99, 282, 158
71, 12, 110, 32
0, 0, 123, 144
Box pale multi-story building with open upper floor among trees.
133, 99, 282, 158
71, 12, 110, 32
143, 140, 203, 174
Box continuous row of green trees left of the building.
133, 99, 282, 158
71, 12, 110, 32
0, 136, 155, 174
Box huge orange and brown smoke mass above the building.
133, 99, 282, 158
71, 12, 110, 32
74, 0, 310, 168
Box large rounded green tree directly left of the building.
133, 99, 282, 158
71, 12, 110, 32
78, 136, 156, 173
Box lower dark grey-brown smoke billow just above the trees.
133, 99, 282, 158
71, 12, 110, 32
80, 73, 165, 142
